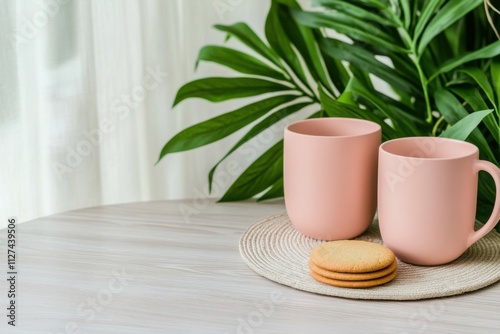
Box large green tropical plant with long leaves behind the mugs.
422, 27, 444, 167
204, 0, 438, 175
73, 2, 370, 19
160, 0, 500, 227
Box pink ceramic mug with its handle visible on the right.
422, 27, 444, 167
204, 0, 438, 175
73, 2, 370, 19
378, 137, 500, 265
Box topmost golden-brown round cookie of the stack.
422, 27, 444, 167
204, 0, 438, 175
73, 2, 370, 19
311, 240, 396, 274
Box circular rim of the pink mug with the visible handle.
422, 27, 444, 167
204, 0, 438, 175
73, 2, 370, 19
379, 136, 479, 161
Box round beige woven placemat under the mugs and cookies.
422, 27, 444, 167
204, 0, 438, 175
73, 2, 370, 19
240, 214, 500, 300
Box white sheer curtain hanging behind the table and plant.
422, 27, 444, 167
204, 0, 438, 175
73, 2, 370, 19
0, 0, 269, 227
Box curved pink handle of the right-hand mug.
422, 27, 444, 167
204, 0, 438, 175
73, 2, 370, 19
467, 160, 500, 247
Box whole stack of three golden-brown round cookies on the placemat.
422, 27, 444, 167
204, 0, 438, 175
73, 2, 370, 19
309, 240, 398, 288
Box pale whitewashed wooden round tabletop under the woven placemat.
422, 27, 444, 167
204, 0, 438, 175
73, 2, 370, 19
0, 200, 500, 334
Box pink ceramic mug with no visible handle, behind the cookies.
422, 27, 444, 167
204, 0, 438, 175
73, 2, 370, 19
283, 118, 381, 240
